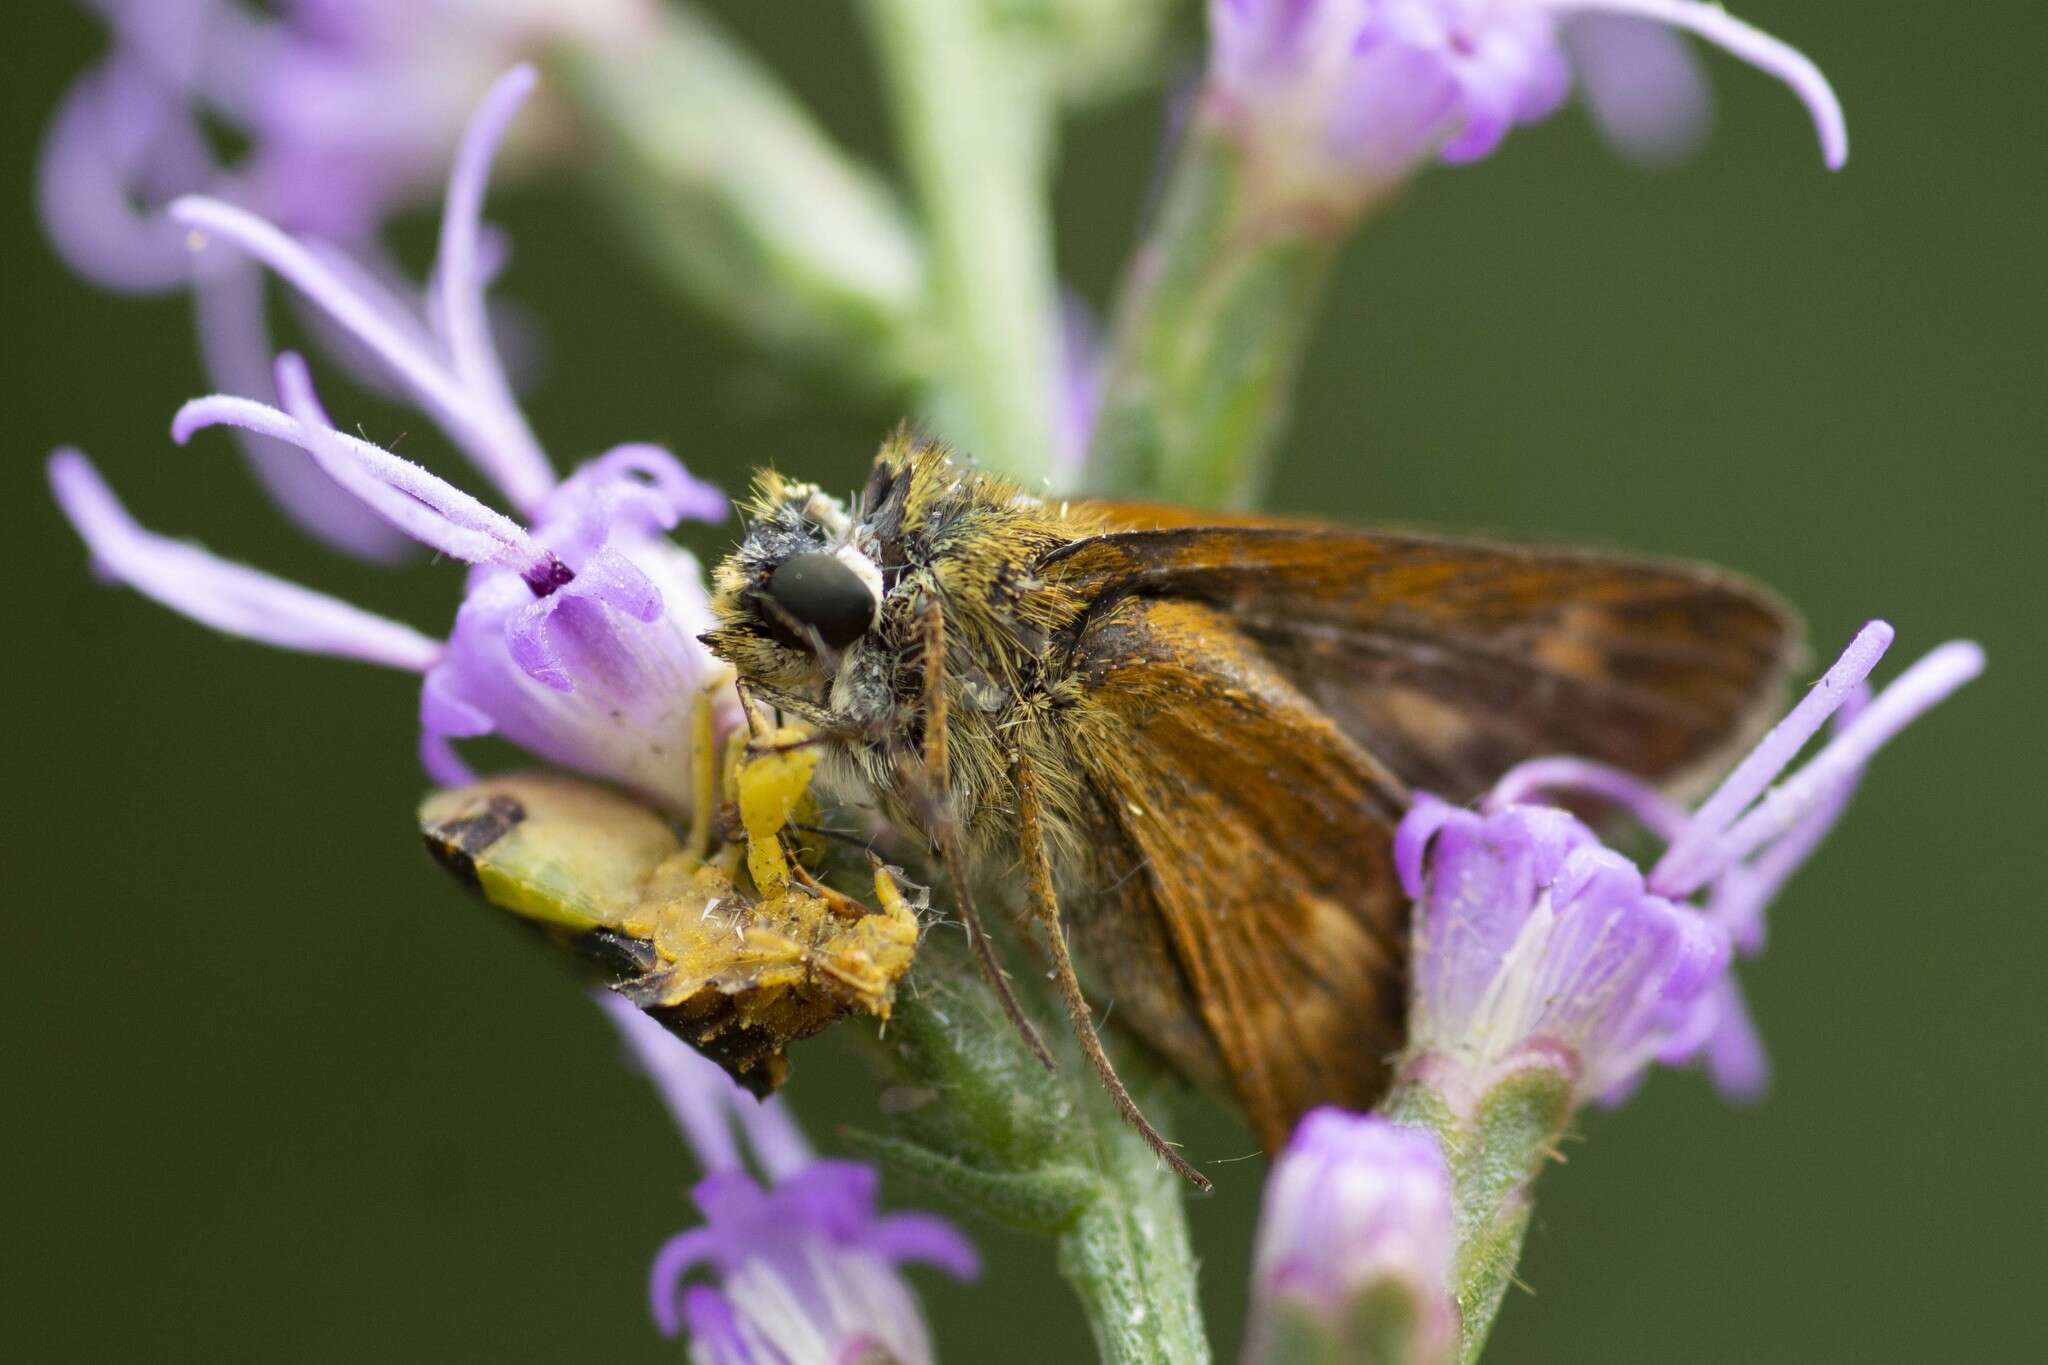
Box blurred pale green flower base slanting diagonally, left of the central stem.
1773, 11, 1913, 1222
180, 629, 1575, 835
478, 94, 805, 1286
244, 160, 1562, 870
553, 6, 932, 387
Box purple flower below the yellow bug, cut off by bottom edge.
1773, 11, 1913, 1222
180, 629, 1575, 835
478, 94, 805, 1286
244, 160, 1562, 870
598, 995, 981, 1365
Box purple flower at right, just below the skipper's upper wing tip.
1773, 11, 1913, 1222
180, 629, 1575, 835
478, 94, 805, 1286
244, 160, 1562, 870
1395, 622, 1985, 1103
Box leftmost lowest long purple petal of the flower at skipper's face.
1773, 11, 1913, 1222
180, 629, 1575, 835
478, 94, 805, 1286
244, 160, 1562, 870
49, 450, 442, 673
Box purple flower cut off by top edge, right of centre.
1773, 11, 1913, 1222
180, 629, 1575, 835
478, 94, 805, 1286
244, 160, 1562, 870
1208, 0, 1847, 201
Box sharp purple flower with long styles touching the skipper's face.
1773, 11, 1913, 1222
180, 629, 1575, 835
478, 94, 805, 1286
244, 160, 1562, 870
49, 68, 737, 810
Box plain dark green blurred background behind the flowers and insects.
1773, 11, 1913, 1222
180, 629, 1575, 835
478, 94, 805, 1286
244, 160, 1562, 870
0, 0, 2048, 1365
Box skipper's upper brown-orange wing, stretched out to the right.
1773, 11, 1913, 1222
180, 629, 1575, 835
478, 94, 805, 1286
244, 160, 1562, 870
1042, 519, 1798, 800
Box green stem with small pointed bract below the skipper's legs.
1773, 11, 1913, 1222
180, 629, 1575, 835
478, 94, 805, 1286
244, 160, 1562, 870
842, 935, 1210, 1365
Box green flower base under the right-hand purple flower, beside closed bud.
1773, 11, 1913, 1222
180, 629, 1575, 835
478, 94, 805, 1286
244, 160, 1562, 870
1380, 1064, 1571, 1365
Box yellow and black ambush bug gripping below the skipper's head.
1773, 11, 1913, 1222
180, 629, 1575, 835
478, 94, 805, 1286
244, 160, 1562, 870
420, 706, 920, 1095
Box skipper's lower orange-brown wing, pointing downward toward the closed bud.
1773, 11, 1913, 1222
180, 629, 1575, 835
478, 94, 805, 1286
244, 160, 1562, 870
1069, 598, 1407, 1148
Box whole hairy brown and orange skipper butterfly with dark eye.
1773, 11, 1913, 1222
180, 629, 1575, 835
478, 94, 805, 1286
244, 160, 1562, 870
705, 436, 1798, 1187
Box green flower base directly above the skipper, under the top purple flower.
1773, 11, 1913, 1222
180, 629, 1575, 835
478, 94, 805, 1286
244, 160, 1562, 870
1085, 117, 1352, 508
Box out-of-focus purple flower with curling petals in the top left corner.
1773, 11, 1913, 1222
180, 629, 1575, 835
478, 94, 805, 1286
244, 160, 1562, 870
37, 0, 657, 559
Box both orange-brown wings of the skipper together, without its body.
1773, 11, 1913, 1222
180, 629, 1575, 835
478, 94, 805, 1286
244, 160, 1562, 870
1040, 508, 1796, 1150
